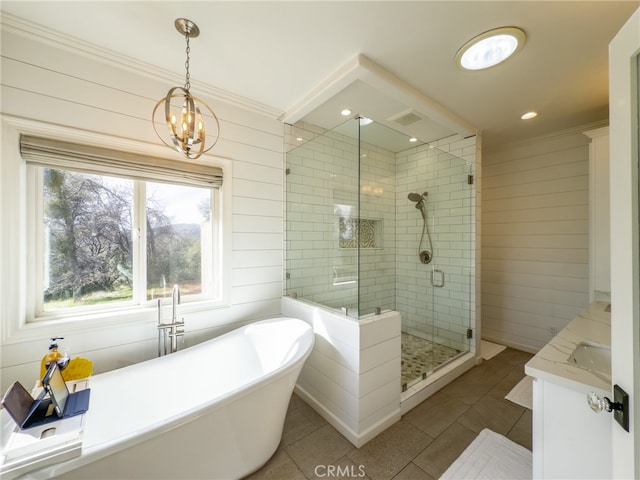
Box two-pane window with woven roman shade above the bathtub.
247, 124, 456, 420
21, 136, 222, 320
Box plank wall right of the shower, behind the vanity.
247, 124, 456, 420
482, 128, 589, 352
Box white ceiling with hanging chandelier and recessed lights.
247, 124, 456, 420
0, 0, 640, 145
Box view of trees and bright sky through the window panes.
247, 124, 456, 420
42, 168, 213, 312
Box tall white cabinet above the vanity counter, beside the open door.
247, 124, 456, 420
584, 127, 611, 301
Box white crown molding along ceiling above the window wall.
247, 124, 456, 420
0, 11, 283, 119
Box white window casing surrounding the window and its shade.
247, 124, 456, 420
0, 114, 232, 343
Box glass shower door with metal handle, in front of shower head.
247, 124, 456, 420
397, 145, 475, 390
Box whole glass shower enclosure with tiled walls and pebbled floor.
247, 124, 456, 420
285, 118, 475, 390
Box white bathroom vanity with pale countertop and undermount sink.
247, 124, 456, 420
525, 301, 612, 479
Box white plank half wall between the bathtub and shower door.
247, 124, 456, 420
282, 297, 401, 447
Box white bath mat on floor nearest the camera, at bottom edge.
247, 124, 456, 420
440, 428, 533, 480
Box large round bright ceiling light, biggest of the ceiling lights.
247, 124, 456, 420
455, 27, 527, 70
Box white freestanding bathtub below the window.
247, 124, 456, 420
26, 318, 314, 480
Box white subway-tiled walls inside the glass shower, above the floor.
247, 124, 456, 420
285, 122, 476, 350
